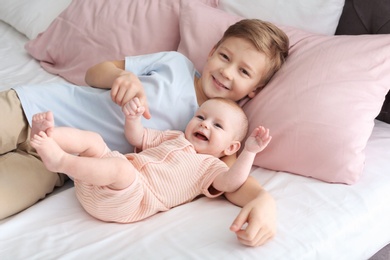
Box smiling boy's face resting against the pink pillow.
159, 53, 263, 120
201, 37, 267, 101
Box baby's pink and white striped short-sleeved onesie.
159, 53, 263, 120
75, 129, 228, 223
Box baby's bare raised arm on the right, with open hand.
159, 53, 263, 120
213, 126, 272, 192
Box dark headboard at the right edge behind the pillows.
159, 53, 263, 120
336, 0, 390, 123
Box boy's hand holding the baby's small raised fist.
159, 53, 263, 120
111, 71, 151, 119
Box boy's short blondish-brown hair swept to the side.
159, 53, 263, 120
215, 19, 289, 87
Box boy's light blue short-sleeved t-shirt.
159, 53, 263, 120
14, 52, 198, 153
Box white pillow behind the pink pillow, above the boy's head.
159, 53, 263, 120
219, 0, 345, 35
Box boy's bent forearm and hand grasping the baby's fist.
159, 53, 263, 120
85, 60, 151, 119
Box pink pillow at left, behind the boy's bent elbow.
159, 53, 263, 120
25, 0, 218, 85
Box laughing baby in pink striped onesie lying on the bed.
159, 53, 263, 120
31, 98, 271, 223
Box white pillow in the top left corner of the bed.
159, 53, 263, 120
0, 0, 72, 39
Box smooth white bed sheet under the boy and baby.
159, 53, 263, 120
0, 19, 390, 260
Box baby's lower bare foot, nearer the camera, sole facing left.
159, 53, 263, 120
30, 131, 66, 172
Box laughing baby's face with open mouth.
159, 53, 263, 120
185, 100, 240, 158
